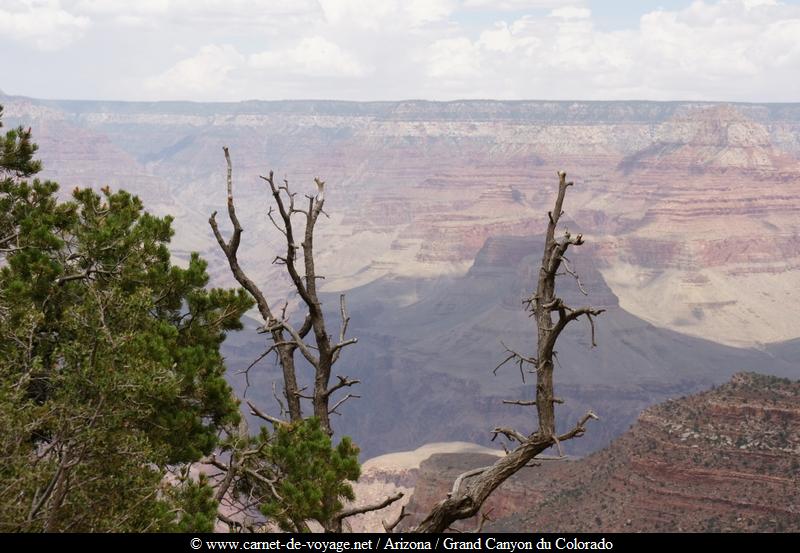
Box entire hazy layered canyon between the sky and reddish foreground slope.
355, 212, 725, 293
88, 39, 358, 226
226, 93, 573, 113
0, 91, 800, 458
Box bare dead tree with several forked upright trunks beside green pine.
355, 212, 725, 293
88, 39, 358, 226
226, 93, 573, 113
208, 147, 402, 531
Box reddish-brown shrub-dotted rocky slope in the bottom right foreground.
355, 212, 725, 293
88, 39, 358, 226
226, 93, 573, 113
407, 373, 800, 532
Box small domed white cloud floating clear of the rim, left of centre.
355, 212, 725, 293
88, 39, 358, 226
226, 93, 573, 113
248, 36, 368, 77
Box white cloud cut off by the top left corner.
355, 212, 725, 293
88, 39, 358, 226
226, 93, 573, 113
0, 0, 91, 50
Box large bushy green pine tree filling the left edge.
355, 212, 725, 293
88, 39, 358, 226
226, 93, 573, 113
0, 103, 252, 531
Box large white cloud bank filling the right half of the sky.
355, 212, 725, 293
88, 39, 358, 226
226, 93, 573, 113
418, 0, 800, 101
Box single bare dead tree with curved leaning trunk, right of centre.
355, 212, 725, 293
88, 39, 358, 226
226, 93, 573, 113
413, 172, 604, 532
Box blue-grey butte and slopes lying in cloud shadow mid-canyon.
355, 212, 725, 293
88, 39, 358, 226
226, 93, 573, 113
300, 237, 798, 455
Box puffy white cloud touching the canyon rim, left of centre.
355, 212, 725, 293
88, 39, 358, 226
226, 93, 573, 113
145, 44, 245, 100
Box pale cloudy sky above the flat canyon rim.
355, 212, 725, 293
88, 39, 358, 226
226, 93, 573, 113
0, 0, 800, 102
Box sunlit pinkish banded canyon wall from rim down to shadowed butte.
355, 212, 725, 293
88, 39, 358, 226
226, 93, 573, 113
2, 97, 800, 345
